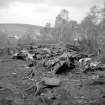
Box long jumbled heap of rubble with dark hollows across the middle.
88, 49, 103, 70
12, 45, 104, 74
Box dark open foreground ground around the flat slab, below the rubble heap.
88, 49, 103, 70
0, 57, 105, 105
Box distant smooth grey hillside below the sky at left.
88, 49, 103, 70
0, 24, 42, 36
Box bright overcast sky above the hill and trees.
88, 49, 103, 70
0, 0, 104, 26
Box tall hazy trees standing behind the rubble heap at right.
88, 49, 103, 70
39, 3, 105, 52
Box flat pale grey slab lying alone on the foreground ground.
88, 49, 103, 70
42, 77, 61, 86
